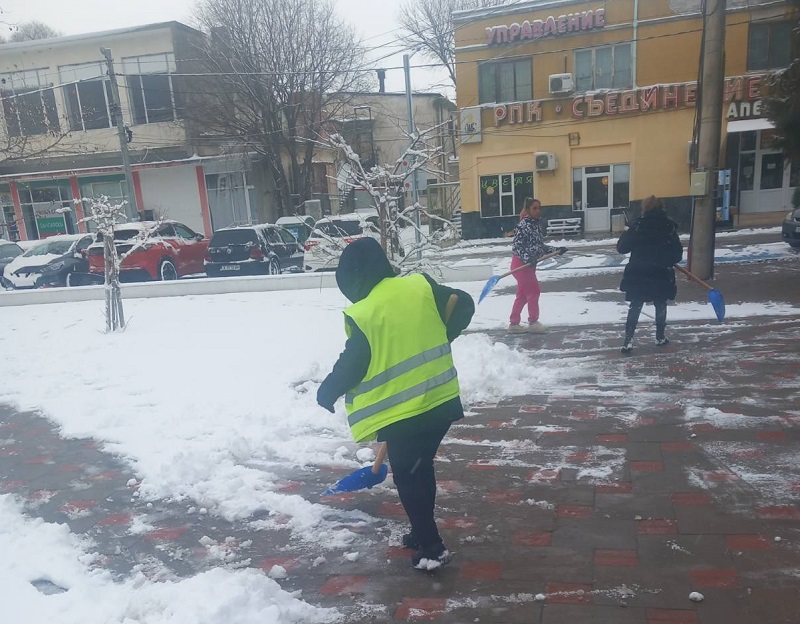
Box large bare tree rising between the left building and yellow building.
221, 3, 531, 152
194, 0, 365, 214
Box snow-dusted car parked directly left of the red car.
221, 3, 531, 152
3, 234, 93, 289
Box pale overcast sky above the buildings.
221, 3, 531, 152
0, 0, 452, 96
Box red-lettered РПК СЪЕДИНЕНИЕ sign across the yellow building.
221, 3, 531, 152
494, 76, 763, 126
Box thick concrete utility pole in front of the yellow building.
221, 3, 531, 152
689, 0, 726, 279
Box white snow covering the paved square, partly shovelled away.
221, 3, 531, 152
0, 236, 800, 624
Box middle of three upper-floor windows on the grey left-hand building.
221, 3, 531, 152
58, 63, 114, 131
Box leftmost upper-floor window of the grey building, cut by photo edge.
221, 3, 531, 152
0, 69, 60, 137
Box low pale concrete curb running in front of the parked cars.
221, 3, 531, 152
0, 264, 492, 307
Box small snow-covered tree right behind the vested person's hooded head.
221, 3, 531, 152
329, 124, 455, 268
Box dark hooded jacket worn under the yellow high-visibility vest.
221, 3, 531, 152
317, 238, 475, 440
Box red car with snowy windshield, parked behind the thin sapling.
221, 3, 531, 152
86, 221, 208, 281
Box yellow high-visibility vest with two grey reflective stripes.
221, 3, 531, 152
344, 275, 459, 442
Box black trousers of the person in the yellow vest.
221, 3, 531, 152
386, 422, 450, 548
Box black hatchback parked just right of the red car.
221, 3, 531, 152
205, 223, 303, 277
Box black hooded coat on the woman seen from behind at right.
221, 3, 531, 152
617, 208, 683, 302
